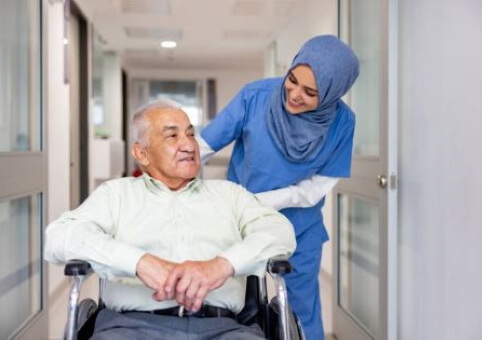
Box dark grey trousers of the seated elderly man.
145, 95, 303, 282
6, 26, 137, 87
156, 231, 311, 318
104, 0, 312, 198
91, 309, 265, 340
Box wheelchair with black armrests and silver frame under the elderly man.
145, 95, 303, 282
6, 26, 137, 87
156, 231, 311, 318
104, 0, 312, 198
64, 258, 305, 340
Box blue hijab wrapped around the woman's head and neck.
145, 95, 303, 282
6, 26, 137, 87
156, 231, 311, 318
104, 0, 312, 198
267, 35, 359, 163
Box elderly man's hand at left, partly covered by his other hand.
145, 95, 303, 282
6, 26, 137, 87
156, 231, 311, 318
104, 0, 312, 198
136, 254, 177, 301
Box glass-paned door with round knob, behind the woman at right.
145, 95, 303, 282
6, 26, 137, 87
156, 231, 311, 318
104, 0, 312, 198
333, 0, 397, 340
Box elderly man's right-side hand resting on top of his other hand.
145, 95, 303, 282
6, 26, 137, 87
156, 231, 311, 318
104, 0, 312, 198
165, 257, 234, 311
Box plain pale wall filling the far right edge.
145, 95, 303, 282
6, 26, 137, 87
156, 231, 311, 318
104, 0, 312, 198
398, 0, 482, 340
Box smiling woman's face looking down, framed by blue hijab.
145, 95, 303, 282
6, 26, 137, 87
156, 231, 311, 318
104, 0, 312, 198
285, 65, 318, 115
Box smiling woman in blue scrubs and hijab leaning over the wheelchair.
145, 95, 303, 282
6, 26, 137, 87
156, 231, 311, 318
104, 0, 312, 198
200, 35, 359, 340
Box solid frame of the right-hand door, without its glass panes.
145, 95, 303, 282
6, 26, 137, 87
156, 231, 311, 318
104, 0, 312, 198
333, 0, 398, 340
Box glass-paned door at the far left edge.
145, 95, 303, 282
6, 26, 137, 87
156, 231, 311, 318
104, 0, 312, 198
0, 0, 47, 339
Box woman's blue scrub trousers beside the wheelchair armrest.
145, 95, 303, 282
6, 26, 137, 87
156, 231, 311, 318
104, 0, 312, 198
285, 233, 325, 340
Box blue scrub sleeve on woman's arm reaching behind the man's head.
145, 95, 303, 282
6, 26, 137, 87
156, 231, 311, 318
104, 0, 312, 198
201, 88, 246, 151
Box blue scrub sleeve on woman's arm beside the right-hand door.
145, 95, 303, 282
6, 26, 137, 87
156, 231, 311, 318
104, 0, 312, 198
317, 118, 355, 177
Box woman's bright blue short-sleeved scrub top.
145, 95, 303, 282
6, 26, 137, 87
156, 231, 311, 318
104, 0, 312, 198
201, 78, 355, 246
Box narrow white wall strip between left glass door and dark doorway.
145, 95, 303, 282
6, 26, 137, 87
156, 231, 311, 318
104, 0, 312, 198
44, 2, 70, 339
